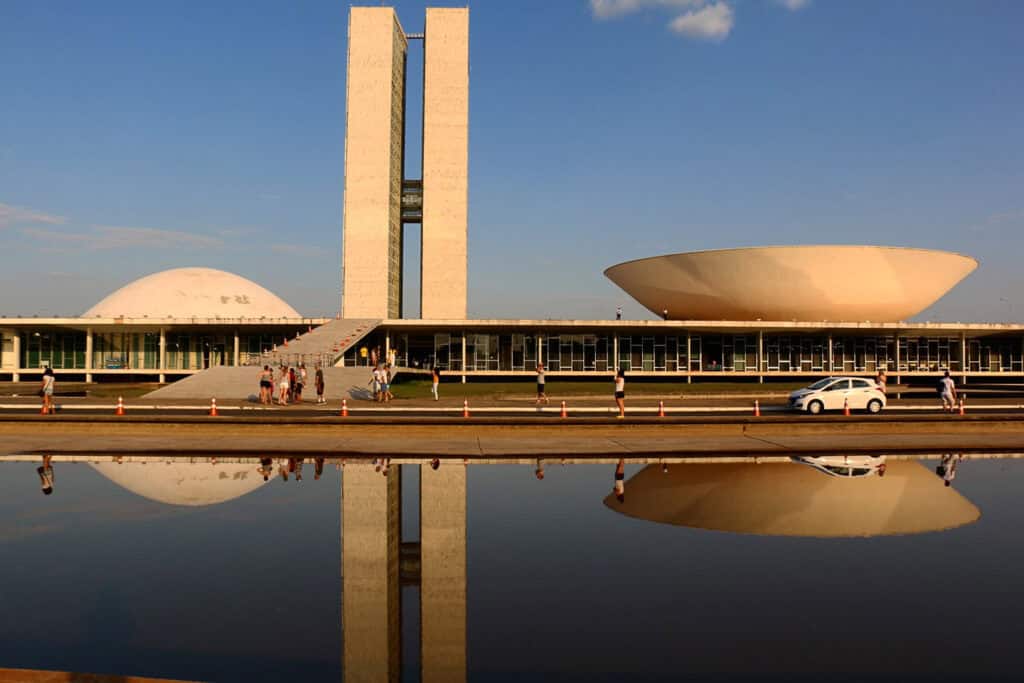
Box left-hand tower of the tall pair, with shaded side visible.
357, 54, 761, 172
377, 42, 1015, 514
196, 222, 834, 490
342, 7, 408, 317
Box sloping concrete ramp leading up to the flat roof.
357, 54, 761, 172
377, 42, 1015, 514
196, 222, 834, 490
145, 318, 380, 400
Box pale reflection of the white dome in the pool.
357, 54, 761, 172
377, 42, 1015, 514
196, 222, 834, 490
92, 462, 266, 506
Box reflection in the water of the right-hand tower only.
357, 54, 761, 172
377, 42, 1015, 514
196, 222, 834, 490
420, 464, 467, 683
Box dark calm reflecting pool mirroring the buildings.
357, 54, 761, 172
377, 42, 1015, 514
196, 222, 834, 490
0, 450, 1024, 681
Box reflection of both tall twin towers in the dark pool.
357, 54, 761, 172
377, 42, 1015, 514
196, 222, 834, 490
341, 464, 466, 681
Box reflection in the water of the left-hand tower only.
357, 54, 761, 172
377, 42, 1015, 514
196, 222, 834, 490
341, 465, 401, 683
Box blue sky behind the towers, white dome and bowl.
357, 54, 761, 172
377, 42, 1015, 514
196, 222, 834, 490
0, 0, 1024, 321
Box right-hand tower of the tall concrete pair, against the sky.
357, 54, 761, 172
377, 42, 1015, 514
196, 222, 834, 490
420, 7, 469, 319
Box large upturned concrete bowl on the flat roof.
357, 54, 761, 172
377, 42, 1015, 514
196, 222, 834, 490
604, 246, 978, 323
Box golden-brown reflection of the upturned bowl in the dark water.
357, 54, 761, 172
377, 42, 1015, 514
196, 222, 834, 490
604, 460, 981, 537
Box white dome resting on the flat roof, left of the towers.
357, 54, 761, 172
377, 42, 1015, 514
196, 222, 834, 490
83, 268, 301, 317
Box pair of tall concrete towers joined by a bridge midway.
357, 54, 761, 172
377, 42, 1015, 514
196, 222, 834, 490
341, 7, 469, 319
